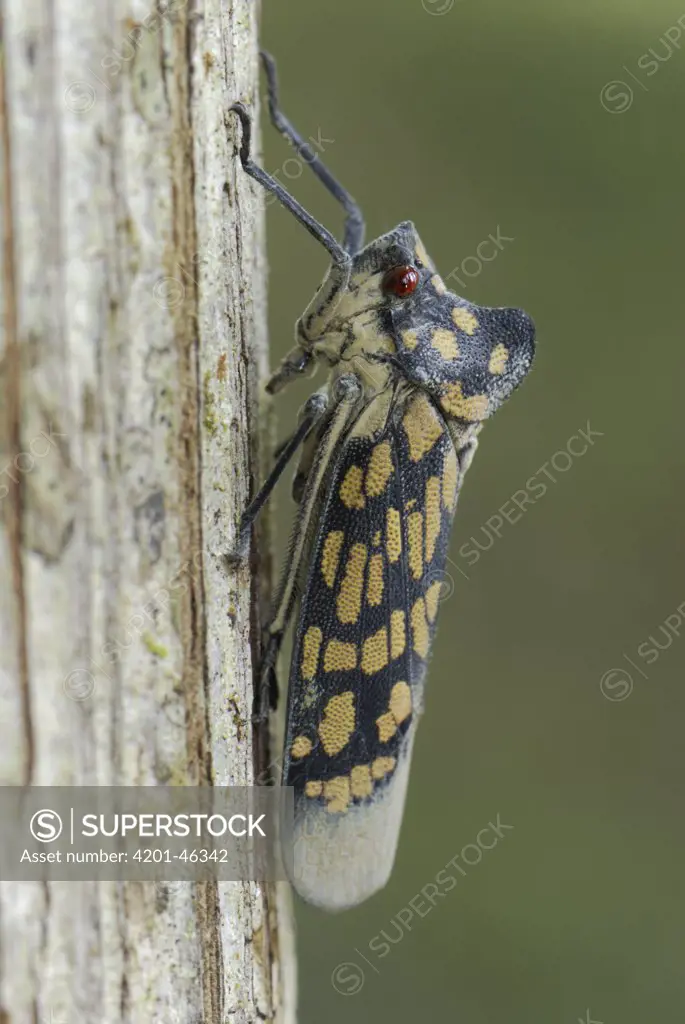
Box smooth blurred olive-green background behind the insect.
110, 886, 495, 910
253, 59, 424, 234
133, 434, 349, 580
262, 0, 685, 1024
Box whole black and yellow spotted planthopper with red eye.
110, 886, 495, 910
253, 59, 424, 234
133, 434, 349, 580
232, 55, 534, 909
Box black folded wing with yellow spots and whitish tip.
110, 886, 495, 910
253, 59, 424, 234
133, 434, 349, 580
284, 385, 459, 909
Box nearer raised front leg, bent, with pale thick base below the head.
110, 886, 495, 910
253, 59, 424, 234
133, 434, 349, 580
230, 103, 352, 394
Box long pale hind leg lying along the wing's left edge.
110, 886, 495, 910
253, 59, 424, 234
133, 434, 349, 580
258, 374, 361, 721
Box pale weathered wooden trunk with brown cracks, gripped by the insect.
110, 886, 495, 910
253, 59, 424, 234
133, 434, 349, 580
0, 0, 294, 1024
